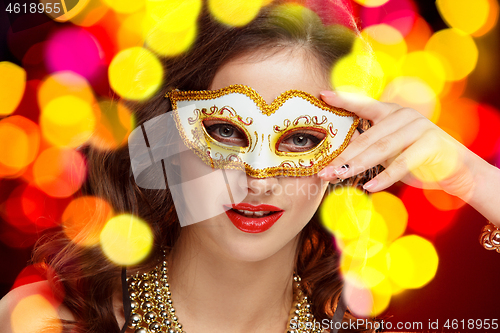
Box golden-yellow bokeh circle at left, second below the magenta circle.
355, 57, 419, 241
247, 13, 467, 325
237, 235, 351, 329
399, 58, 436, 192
40, 95, 96, 148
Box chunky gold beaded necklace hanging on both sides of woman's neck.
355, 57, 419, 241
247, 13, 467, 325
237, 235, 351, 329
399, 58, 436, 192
127, 260, 323, 333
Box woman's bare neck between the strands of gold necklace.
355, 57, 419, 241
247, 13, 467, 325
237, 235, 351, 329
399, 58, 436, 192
168, 228, 298, 333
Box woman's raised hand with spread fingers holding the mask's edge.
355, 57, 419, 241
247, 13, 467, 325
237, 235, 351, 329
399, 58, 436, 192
319, 91, 489, 200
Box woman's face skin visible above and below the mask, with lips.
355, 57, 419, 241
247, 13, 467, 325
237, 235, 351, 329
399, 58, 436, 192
181, 48, 330, 261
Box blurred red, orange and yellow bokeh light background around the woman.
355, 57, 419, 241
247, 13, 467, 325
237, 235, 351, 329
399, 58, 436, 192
0, 0, 500, 327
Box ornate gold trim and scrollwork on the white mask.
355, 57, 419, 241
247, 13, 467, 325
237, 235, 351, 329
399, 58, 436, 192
165, 84, 359, 178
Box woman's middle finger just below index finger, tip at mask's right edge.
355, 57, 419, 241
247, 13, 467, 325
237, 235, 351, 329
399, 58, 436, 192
325, 108, 429, 178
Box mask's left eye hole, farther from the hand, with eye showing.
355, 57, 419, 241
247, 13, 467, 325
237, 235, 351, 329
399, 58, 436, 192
203, 119, 249, 147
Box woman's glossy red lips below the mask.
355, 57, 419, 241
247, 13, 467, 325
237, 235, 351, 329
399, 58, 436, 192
225, 202, 284, 233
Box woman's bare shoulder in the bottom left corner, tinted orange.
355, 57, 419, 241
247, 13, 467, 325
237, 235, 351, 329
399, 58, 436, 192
0, 281, 74, 333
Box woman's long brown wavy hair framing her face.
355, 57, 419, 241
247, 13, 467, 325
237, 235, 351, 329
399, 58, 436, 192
33, 1, 378, 333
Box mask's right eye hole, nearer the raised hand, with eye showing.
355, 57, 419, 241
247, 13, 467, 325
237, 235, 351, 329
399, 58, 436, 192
276, 128, 326, 153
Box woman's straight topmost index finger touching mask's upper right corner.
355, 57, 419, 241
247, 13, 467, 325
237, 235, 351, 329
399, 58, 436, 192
320, 90, 401, 123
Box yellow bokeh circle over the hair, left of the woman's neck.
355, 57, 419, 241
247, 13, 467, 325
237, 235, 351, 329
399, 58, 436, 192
100, 214, 153, 266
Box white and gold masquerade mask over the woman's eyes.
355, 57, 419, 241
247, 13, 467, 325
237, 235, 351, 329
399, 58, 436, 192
167, 85, 359, 178
